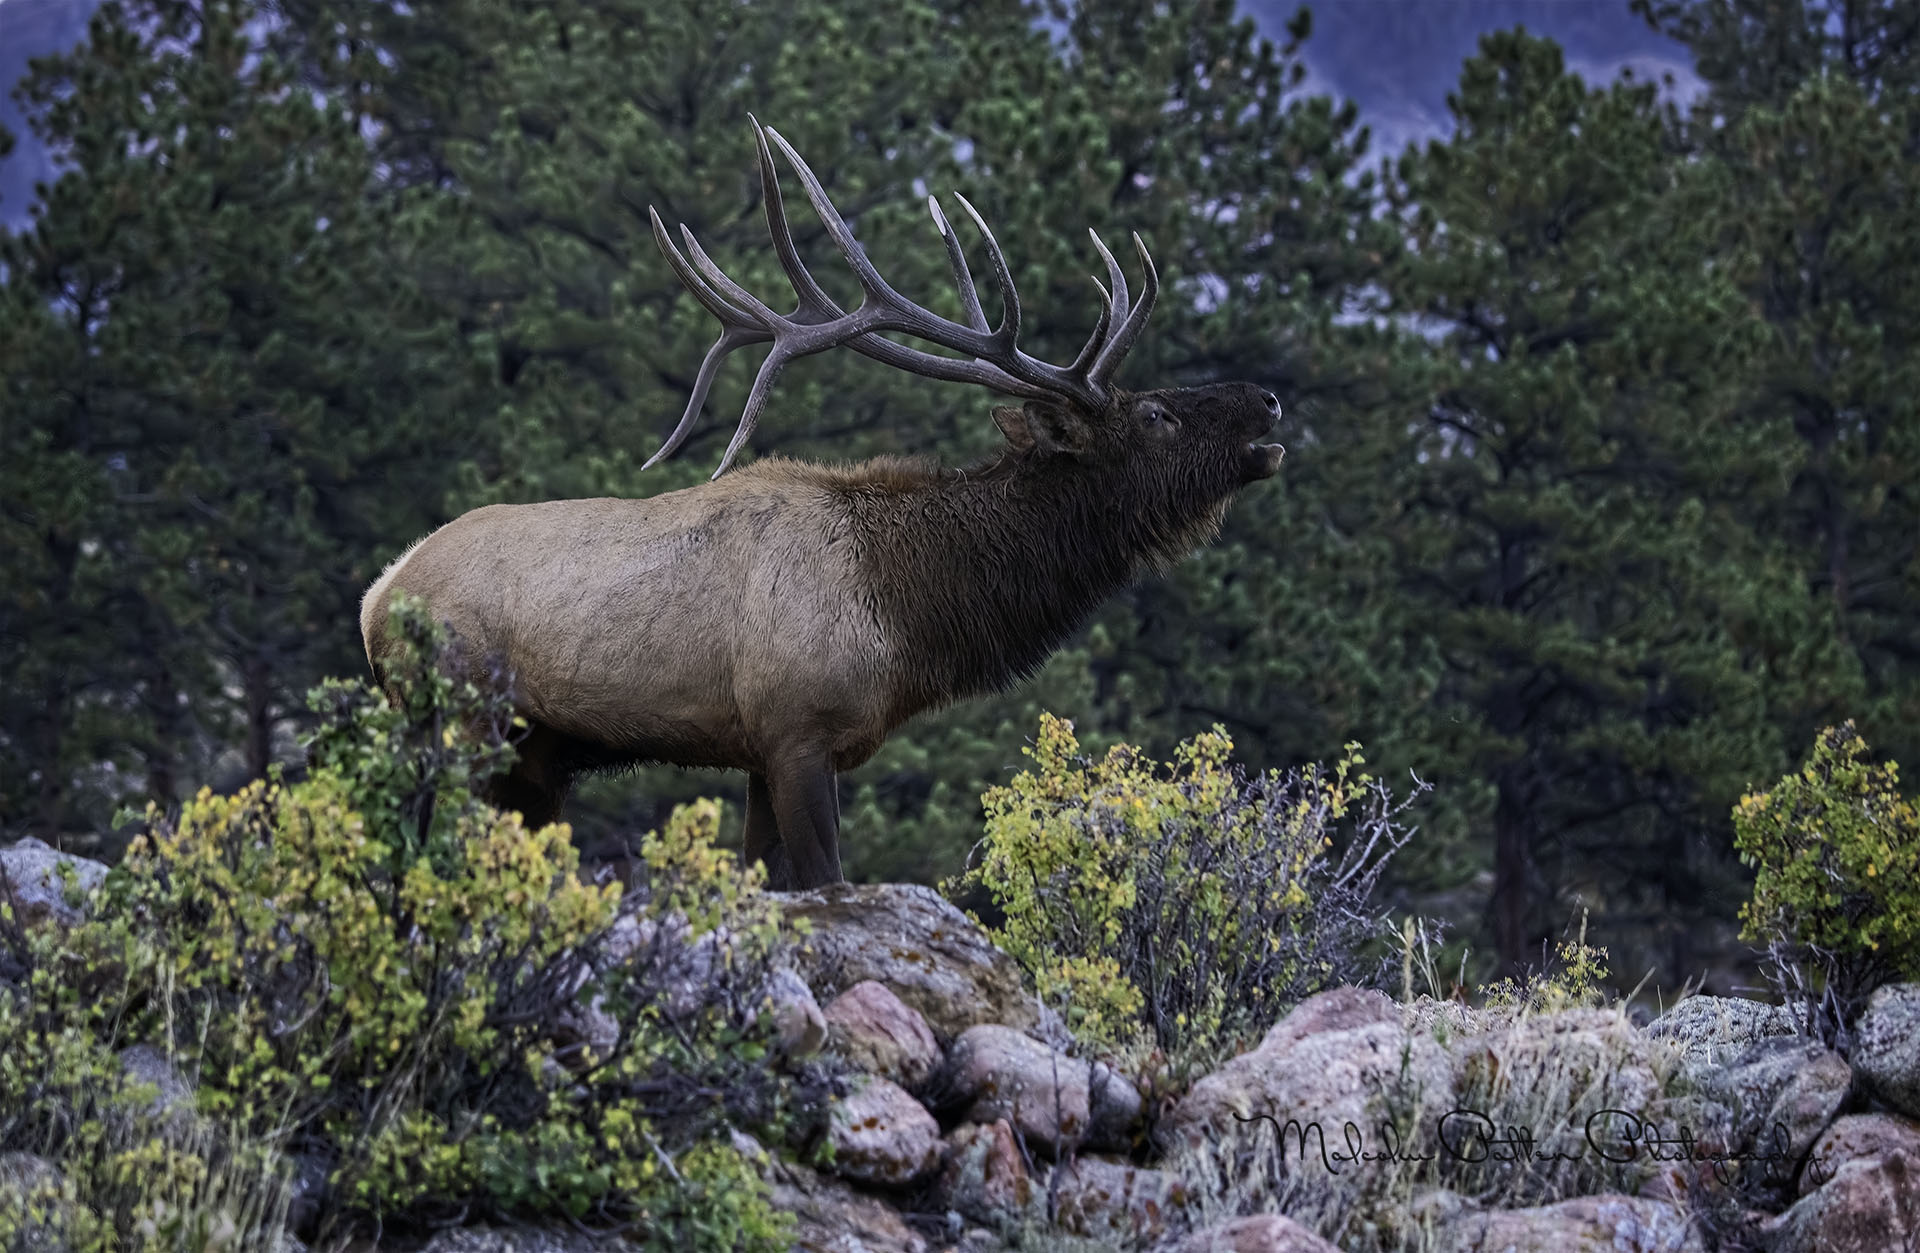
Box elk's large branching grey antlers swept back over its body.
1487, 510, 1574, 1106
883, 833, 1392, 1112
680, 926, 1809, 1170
641, 117, 1160, 478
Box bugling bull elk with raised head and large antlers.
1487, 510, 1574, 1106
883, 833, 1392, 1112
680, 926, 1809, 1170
361, 121, 1284, 887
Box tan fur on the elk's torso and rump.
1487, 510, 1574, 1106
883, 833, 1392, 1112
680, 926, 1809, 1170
372, 461, 895, 773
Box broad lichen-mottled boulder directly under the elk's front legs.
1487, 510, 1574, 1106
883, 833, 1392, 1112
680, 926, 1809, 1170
772, 883, 1041, 1040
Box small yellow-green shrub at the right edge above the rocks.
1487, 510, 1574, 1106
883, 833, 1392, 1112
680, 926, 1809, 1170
1734, 721, 1920, 1038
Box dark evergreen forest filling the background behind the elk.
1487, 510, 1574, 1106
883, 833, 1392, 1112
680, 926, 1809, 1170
0, 0, 1920, 992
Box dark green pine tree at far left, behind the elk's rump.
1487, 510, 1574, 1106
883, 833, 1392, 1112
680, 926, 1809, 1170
4, 0, 455, 831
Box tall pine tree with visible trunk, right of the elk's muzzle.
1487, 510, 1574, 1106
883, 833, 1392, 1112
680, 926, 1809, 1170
1379, 33, 1845, 969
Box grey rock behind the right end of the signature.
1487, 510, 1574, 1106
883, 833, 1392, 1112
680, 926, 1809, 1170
1701, 1036, 1853, 1190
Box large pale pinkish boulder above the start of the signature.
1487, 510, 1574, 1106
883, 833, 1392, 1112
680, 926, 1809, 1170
1162, 988, 1453, 1159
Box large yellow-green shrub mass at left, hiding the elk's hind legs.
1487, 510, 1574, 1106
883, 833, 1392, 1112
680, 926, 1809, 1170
0, 604, 828, 1251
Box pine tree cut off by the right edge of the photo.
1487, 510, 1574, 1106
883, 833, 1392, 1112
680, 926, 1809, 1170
1636, 0, 1920, 760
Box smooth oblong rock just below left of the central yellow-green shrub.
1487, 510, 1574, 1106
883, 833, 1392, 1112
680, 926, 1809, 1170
937, 1023, 1142, 1153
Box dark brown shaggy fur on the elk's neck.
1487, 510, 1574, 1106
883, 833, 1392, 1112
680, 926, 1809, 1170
831, 453, 1231, 720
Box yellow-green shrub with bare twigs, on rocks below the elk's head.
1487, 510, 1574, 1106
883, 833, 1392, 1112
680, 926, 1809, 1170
960, 716, 1425, 1059
